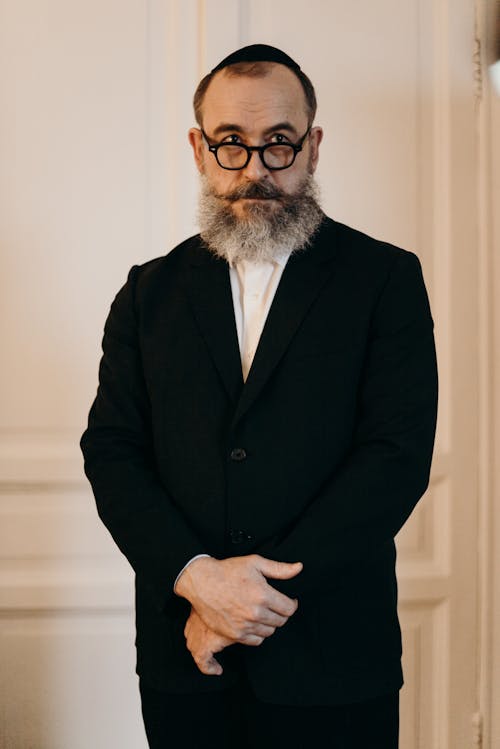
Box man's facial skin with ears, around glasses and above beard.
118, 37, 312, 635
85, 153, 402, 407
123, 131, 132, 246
189, 64, 323, 217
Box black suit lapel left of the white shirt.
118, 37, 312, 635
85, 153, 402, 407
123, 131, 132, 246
185, 245, 243, 403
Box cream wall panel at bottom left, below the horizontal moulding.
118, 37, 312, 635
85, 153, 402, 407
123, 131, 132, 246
0, 608, 143, 749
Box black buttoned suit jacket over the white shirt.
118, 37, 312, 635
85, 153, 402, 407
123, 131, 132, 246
82, 218, 437, 704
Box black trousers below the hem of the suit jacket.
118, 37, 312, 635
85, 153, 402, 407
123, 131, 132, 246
139, 681, 399, 749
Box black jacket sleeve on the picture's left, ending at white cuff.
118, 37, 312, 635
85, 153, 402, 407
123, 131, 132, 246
81, 267, 206, 610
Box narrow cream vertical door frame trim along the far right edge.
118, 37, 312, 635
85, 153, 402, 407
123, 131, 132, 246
472, 0, 500, 747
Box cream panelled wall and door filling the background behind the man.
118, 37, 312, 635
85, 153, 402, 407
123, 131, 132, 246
0, 0, 500, 749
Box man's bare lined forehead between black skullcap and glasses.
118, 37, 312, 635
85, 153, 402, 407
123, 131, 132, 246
202, 64, 307, 133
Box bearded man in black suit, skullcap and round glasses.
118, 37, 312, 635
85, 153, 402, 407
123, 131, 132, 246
82, 45, 437, 749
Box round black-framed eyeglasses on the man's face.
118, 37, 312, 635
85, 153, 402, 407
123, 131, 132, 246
201, 127, 311, 171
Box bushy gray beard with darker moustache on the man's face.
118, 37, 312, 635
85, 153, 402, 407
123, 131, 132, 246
198, 174, 324, 264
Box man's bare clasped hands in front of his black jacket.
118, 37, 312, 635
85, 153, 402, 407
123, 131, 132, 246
175, 554, 302, 675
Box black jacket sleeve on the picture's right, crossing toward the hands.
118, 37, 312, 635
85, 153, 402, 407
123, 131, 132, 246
259, 252, 438, 596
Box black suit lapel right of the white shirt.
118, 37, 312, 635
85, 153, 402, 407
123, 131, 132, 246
233, 220, 335, 424
